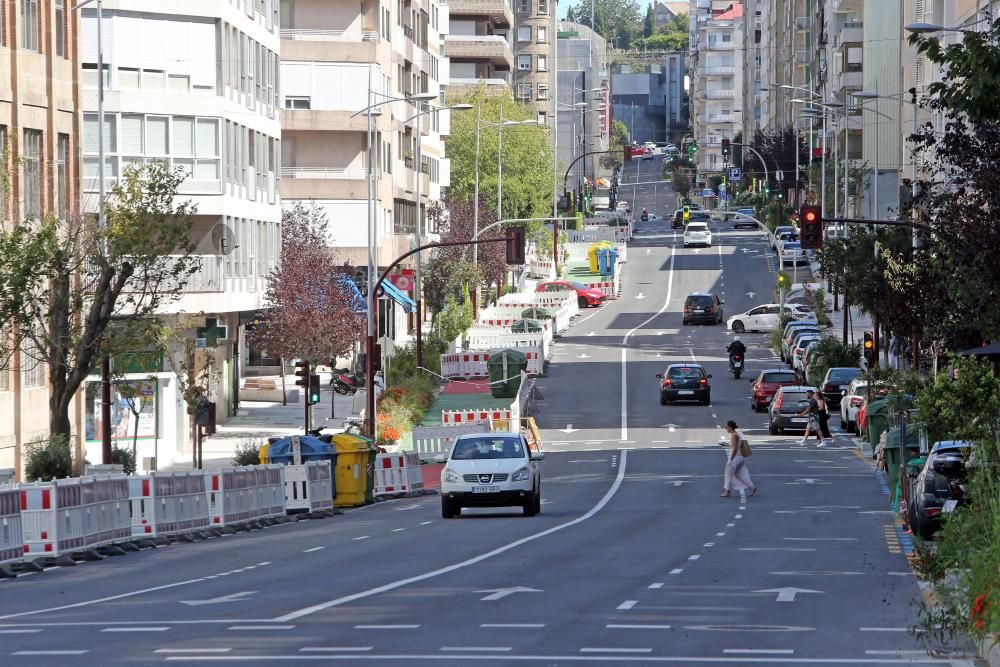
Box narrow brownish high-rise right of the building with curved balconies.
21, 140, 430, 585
514, 0, 557, 125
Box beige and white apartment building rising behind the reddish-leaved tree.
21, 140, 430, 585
281, 0, 454, 344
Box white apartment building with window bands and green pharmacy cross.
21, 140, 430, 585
80, 0, 281, 467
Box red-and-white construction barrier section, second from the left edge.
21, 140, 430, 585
19, 475, 131, 558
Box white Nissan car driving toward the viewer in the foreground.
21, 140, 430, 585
441, 433, 545, 519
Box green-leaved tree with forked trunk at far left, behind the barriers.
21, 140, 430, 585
0, 161, 200, 439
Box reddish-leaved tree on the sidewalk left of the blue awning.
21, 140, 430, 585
249, 203, 368, 374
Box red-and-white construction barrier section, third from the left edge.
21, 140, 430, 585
128, 471, 210, 537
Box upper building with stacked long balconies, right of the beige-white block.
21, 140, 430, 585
445, 0, 514, 88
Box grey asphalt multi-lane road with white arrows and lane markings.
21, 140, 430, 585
0, 176, 968, 666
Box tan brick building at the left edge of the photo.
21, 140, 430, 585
0, 0, 80, 474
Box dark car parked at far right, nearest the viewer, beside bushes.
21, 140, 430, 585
907, 440, 972, 540
